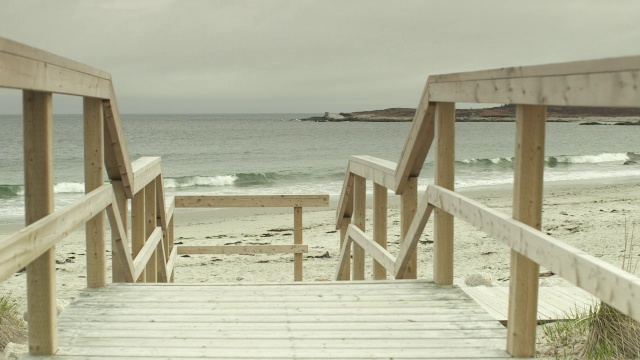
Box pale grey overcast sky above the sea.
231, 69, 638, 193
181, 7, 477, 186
0, 0, 640, 114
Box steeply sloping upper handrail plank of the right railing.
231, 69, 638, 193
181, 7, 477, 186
395, 95, 435, 195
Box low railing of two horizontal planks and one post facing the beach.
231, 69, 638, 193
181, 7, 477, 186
172, 195, 329, 281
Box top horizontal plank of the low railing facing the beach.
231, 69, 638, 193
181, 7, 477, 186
175, 195, 329, 208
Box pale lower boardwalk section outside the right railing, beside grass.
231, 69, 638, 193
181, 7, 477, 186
461, 286, 597, 324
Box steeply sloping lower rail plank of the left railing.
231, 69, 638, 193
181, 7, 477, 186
106, 198, 135, 282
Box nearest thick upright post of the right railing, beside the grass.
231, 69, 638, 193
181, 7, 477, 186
507, 105, 547, 357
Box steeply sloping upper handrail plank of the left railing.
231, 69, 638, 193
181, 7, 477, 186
102, 84, 133, 199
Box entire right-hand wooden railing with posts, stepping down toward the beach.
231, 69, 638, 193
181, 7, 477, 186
336, 56, 640, 357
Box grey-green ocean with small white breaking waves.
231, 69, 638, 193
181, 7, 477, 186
0, 114, 640, 223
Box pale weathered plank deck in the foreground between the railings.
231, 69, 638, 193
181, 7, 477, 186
26, 280, 509, 359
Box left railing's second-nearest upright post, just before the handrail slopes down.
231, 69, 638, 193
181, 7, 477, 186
83, 97, 105, 288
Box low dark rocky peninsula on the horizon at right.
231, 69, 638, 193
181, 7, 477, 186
300, 104, 640, 125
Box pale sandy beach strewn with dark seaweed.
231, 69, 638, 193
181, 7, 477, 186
0, 180, 640, 316
